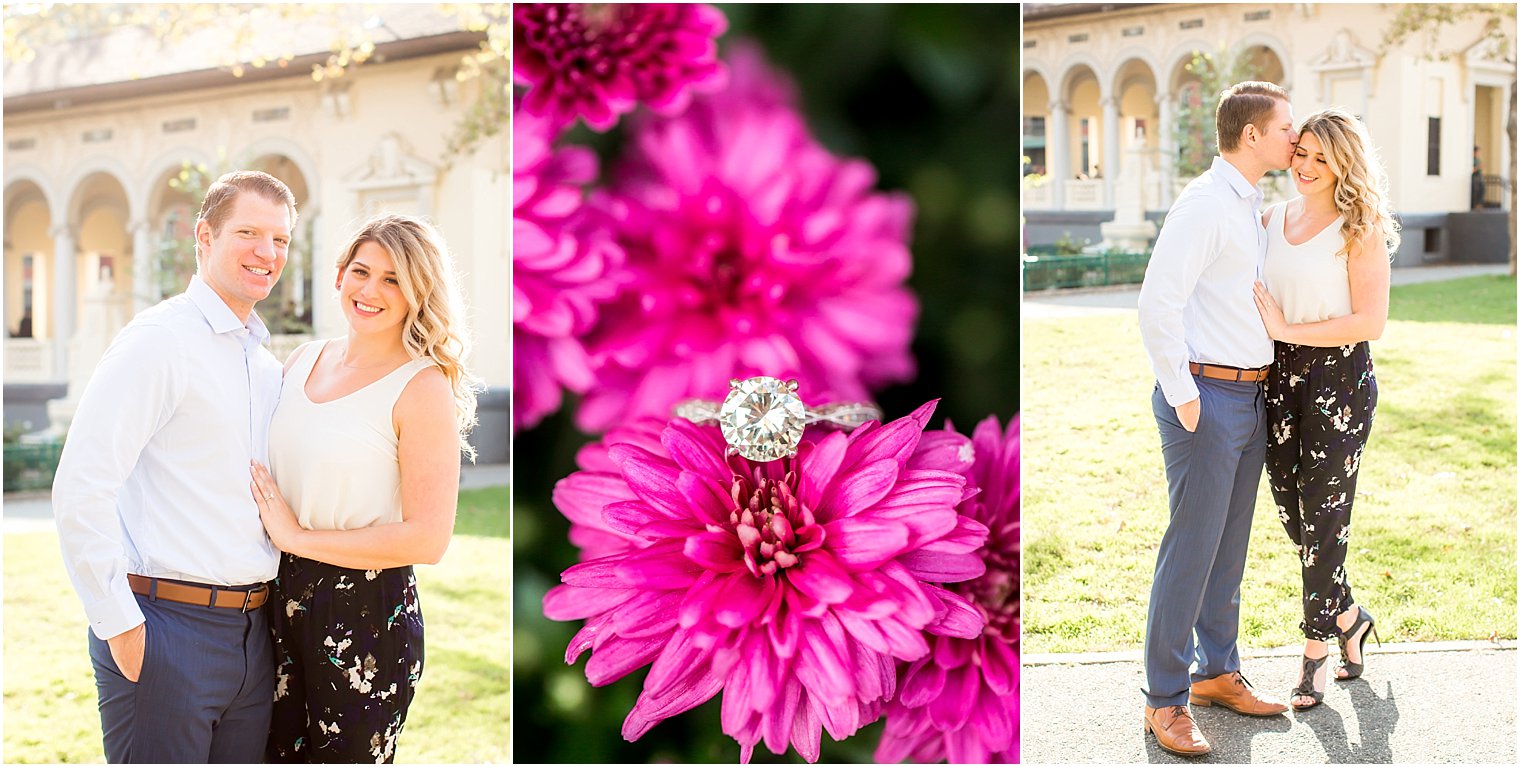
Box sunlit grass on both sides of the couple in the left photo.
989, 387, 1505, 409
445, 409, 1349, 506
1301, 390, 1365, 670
5, 488, 511, 764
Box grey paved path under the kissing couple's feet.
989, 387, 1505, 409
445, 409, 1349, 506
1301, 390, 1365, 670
1020, 641, 1515, 764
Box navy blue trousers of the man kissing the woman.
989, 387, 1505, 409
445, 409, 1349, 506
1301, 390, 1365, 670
1145, 375, 1266, 708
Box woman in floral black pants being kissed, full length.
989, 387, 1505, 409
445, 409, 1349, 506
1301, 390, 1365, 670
1256, 109, 1398, 709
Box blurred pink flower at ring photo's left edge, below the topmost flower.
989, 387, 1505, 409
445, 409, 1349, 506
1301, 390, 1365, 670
512, 111, 623, 428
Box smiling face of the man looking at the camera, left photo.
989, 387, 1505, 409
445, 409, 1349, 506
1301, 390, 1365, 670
195, 191, 290, 322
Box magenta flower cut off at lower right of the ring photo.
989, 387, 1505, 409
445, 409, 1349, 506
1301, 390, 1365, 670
876, 418, 1018, 764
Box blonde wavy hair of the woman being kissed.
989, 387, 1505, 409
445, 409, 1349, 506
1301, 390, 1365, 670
1298, 109, 1400, 260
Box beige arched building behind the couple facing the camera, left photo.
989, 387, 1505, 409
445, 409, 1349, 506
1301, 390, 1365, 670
3, 6, 511, 459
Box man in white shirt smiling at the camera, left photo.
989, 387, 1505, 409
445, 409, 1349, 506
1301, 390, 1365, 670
53, 172, 296, 762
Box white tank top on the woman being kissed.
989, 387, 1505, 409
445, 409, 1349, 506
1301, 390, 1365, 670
1262, 202, 1351, 325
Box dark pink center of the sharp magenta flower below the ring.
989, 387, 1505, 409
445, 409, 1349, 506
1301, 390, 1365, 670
728, 459, 824, 577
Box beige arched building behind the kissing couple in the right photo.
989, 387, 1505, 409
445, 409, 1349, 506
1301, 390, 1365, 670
1020, 3, 1515, 259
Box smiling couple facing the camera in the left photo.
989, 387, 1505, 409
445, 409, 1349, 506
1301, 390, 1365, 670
53, 172, 474, 762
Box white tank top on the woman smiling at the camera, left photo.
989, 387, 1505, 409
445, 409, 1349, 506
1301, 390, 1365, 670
269, 342, 433, 530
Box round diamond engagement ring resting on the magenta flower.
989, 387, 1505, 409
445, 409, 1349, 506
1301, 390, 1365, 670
675, 375, 882, 462
